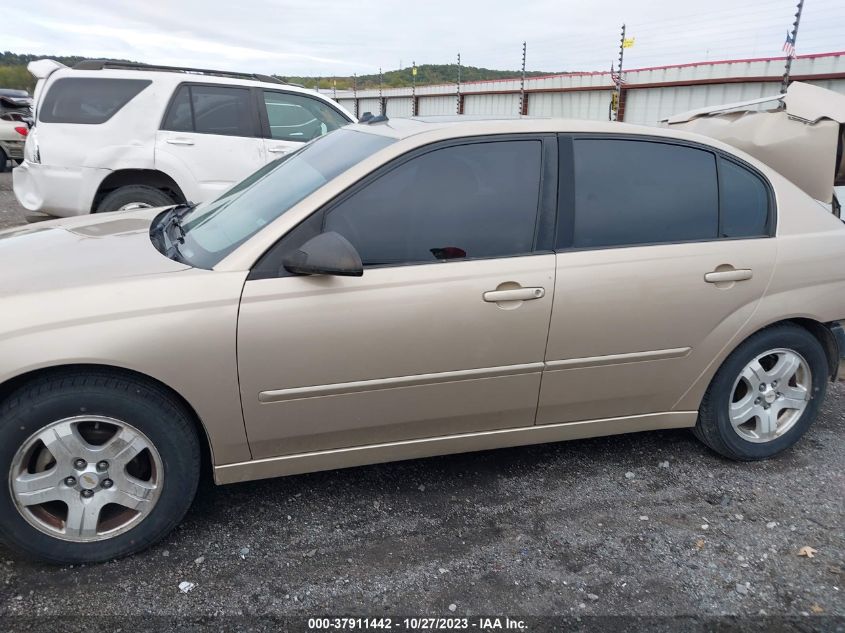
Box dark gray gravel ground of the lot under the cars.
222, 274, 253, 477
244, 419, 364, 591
0, 174, 845, 631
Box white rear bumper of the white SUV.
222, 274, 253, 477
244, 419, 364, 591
12, 160, 109, 217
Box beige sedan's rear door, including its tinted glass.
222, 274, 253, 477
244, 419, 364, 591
537, 137, 776, 426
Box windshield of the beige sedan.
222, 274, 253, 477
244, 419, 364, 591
174, 129, 395, 268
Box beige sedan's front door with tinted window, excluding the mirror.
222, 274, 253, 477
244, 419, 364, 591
238, 137, 556, 458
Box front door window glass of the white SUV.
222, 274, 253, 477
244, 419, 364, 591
264, 91, 349, 142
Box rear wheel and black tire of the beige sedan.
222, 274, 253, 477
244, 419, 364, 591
693, 324, 830, 461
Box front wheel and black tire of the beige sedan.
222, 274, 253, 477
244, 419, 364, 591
0, 371, 200, 564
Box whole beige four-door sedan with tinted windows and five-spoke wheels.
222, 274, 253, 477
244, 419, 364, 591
0, 117, 845, 563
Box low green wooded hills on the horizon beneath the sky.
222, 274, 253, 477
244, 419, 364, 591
0, 51, 564, 92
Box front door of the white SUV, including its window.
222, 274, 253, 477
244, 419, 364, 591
261, 90, 351, 162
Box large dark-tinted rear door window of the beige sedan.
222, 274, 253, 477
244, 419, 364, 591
563, 139, 719, 247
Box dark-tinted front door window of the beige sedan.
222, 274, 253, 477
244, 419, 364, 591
325, 141, 542, 265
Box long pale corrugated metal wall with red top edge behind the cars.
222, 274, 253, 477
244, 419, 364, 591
338, 53, 845, 125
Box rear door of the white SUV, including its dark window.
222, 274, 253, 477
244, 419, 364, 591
155, 84, 266, 202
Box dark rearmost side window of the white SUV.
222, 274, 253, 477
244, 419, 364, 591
38, 77, 152, 124
